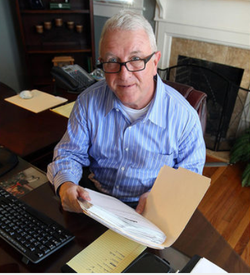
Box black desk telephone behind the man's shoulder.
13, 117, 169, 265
51, 64, 96, 93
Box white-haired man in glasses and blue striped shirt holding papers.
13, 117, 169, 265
47, 11, 205, 213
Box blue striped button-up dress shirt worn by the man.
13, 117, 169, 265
47, 76, 206, 202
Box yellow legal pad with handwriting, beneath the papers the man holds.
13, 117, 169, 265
67, 230, 146, 273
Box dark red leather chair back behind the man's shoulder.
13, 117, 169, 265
163, 80, 207, 135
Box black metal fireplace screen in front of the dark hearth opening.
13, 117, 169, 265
159, 56, 244, 151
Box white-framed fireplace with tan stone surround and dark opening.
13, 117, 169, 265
155, 0, 250, 151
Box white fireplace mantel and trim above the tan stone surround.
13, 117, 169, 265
155, 0, 250, 68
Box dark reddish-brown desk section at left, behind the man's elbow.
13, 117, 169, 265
0, 83, 77, 168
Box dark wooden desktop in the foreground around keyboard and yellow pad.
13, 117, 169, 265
0, 160, 250, 273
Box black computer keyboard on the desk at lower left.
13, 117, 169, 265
0, 187, 74, 263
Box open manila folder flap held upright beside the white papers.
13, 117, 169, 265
143, 166, 211, 249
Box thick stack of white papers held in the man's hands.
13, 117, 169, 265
79, 188, 166, 248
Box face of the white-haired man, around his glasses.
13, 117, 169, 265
100, 30, 161, 109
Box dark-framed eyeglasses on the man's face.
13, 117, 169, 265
97, 52, 155, 74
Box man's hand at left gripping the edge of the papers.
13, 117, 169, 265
59, 181, 90, 213
